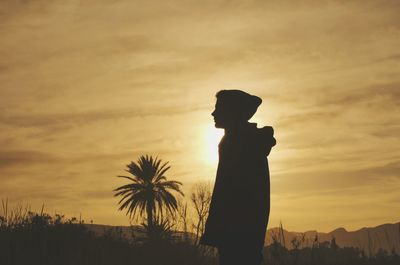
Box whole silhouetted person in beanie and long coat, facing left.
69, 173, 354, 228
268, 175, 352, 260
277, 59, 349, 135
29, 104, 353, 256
200, 90, 276, 265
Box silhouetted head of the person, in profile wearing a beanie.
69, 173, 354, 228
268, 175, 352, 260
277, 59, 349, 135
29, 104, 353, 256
211, 90, 262, 128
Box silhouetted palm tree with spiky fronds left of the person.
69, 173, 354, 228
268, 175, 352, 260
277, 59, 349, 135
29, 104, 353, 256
114, 155, 184, 232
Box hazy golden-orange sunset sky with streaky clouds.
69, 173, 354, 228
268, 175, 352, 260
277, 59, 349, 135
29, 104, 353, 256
0, 0, 400, 231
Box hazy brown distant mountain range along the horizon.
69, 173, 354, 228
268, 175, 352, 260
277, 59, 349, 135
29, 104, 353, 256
85, 222, 400, 254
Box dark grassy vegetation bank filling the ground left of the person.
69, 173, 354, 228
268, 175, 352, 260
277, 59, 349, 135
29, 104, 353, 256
0, 208, 216, 265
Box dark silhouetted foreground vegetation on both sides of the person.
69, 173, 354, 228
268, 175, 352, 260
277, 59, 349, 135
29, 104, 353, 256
0, 207, 400, 265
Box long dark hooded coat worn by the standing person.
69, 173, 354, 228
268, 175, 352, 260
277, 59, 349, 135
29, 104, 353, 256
200, 123, 276, 247
